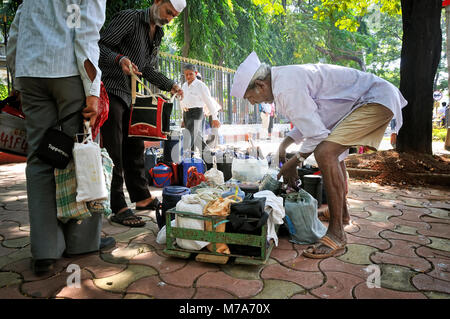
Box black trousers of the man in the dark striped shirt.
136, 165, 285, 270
101, 93, 151, 214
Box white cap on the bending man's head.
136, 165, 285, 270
231, 52, 261, 98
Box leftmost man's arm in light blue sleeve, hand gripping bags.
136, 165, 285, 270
74, 0, 106, 126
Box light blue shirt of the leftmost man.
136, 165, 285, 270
7, 0, 106, 96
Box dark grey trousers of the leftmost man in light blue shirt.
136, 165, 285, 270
16, 76, 102, 259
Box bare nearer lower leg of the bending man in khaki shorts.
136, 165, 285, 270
314, 141, 348, 254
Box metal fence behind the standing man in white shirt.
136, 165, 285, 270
142, 52, 259, 124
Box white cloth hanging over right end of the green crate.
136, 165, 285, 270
253, 190, 285, 246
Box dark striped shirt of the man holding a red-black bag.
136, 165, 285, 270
99, 8, 175, 105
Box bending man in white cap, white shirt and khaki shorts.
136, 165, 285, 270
231, 52, 407, 258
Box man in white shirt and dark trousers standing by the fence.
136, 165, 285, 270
181, 64, 220, 154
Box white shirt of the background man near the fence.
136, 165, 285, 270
181, 79, 219, 120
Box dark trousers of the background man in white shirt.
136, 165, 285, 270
183, 107, 204, 153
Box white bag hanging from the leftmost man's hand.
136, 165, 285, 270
73, 122, 108, 202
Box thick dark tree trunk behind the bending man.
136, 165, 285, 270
397, 0, 442, 154
